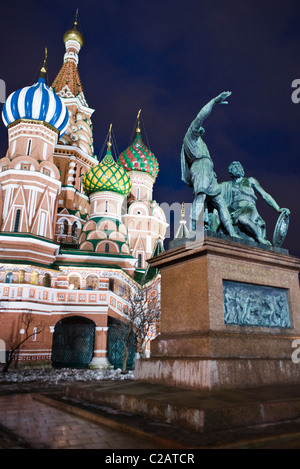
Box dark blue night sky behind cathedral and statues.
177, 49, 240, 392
0, 0, 300, 256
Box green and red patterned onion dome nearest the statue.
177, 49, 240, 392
118, 132, 159, 179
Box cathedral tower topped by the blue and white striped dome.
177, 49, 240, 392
0, 53, 69, 264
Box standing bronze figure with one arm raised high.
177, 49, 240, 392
181, 91, 239, 237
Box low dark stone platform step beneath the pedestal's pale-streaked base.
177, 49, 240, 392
66, 381, 300, 432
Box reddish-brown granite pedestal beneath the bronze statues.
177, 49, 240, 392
135, 236, 300, 390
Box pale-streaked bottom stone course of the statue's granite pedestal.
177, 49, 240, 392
135, 357, 300, 391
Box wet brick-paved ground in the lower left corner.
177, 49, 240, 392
0, 394, 166, 449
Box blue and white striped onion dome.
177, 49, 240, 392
2, 78, 69, 136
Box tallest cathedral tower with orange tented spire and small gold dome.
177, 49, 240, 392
52, 13, 98, 247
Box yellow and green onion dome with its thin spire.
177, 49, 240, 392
82, 124, 131, 195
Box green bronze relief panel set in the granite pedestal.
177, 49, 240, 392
223, 280, 291, 328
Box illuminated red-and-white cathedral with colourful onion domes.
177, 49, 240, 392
0, 18, 167, 367
